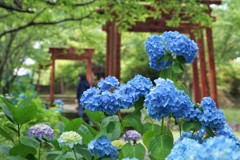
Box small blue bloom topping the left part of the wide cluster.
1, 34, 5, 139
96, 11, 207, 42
97, 76, 119, 91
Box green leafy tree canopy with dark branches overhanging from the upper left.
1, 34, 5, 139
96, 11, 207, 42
0, 0, 210, 92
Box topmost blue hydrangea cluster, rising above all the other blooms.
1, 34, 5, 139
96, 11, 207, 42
145, 31, 198, 70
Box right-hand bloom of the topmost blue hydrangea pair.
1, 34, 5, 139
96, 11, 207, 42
163, 31, 198, 63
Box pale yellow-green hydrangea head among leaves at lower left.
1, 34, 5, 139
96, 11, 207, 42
58, 131, 82, 148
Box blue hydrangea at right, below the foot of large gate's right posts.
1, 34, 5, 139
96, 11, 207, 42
199, 97, 226, 130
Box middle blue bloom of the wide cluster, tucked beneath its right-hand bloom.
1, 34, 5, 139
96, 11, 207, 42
115, 84, 139, 109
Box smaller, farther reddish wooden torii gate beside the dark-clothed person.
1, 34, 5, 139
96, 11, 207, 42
49, 47, 94, 104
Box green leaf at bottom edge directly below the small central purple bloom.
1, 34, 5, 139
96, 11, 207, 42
122, 143, 146, 159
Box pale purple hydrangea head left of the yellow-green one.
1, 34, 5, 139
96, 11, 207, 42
28, 123, 54, 140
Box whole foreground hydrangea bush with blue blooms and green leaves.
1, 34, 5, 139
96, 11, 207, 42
0, 32, 240, 160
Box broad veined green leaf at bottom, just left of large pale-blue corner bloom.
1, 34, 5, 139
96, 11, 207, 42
149, 135, 173, 160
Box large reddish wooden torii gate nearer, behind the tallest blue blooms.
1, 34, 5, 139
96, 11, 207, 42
103, 0, 221, 103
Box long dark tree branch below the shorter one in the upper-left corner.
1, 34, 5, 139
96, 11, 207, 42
0, 13, 92, 38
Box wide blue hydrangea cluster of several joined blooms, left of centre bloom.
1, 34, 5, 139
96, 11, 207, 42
80, 75, 152, 115
